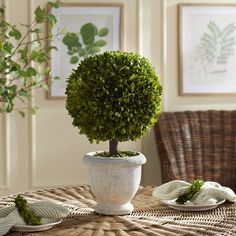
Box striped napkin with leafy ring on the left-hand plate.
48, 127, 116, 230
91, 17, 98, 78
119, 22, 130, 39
0, 202, 70, 236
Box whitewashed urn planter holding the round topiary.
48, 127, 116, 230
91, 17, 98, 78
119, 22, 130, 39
84, 152, 146, 215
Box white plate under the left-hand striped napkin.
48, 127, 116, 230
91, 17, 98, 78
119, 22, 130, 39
11, 218, 62, 232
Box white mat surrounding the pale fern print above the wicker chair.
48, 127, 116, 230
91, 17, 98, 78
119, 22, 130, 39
180, 5, 236, 94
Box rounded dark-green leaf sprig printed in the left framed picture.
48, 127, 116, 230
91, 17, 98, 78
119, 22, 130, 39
62, 22, 109, 64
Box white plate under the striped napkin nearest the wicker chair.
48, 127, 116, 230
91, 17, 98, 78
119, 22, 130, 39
163, 200, 225, 211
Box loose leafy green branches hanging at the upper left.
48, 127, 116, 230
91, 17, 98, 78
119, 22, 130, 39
0, 1, 60, 114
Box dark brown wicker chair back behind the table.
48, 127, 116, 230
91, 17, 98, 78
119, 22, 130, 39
155, 110, 236, 191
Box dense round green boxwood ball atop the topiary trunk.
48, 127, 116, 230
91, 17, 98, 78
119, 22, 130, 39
66, 51, 162, 142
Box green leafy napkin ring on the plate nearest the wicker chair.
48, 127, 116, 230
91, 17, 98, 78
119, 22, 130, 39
176, 179, 204, 204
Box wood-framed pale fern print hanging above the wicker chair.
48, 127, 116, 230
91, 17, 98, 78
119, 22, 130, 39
178, 4, 236, 96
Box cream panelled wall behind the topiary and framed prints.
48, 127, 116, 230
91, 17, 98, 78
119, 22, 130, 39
0, 0, 236, 195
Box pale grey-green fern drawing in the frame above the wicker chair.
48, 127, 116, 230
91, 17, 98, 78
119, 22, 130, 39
196, 21, 236, 75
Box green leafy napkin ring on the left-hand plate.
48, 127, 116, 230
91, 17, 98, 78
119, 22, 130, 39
14, 195, 41, 225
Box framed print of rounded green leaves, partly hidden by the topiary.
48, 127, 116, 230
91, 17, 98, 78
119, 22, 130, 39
47, 3, 124, 99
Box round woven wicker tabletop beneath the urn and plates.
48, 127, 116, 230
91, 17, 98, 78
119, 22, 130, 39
0, 186, 236, 236
